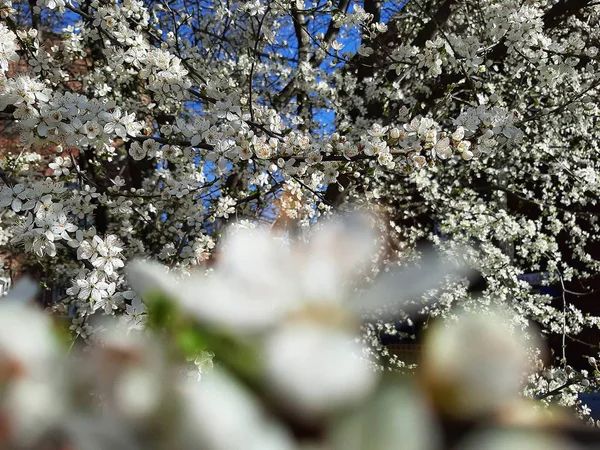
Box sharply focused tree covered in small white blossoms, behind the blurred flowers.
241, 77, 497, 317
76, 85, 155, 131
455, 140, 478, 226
0, 0, 600, 418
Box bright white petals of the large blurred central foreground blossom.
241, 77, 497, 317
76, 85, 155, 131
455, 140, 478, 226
130, 218, 377, 416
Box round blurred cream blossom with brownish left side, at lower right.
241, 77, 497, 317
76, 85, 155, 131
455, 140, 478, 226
420, 310, 541, 419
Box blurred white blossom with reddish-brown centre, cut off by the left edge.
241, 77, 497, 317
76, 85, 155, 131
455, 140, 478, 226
0, 279, 66, 448
